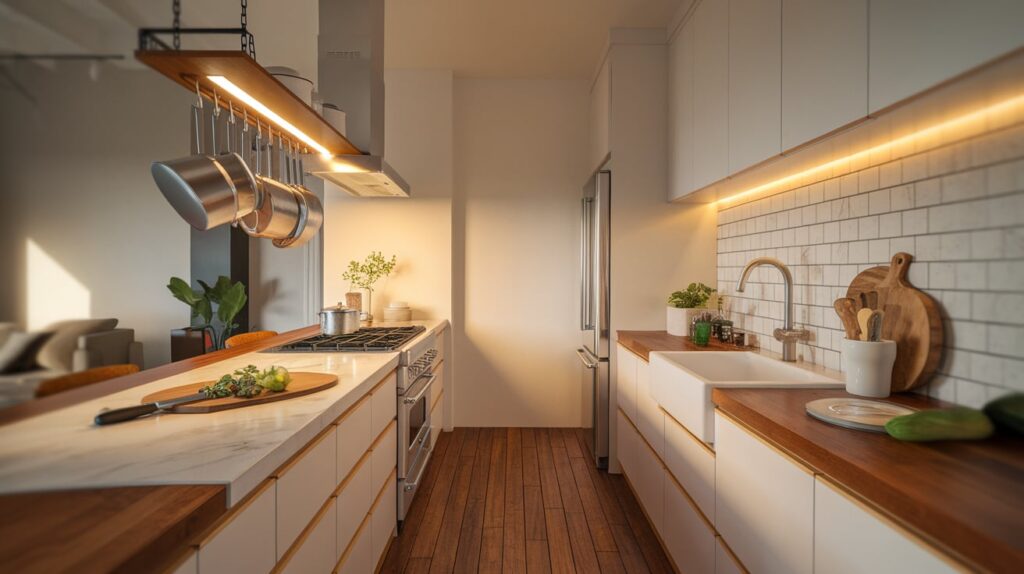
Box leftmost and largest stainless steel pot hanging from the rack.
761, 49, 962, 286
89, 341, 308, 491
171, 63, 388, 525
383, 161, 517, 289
151, 153, 256, 231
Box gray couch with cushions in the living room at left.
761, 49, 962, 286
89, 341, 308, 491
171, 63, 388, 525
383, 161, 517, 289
0, 319, 142, 408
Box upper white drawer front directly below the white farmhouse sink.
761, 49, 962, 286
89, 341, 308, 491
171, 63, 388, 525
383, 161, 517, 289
665, 415, 715, 524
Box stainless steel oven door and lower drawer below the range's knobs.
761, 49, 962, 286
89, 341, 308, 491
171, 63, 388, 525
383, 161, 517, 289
398, 372, 436, 520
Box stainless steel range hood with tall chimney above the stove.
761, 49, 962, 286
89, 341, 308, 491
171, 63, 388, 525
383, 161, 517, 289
308, 0, 410, 197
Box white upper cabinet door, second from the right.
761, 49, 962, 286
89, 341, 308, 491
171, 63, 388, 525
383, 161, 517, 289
782, 0, 867, 150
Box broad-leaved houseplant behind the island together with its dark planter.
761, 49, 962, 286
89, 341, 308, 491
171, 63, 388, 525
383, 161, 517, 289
167, 275, 249, 361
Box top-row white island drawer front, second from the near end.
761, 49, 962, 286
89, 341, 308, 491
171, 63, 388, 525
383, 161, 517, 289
278, 427, 338, 560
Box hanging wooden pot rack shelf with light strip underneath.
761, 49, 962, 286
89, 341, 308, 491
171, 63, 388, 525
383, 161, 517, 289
135, 50, 362, 156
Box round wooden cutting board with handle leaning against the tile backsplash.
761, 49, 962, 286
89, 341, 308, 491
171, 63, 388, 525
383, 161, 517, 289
846, 253, 943, 392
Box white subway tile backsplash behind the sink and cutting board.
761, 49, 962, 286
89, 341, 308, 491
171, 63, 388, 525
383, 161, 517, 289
718, 125, 1024, 405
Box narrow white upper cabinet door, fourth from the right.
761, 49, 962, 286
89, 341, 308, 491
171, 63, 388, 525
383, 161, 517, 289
692, 0, 729, 189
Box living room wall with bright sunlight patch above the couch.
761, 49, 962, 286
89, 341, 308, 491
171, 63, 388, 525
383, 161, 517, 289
0, 63, 189, 365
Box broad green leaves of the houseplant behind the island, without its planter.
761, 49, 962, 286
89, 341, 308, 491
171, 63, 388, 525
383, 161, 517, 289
167, 275, 249, 350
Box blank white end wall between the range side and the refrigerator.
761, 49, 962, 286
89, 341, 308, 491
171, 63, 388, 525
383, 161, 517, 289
453, 79, 589, 427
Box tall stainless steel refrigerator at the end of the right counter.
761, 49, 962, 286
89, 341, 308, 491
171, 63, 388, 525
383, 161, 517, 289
577, 170, 611, 469
